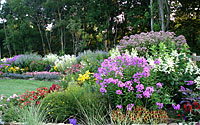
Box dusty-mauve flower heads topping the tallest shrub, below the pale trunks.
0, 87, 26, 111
118, 31, 187, 56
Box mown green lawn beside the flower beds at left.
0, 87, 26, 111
0, 79, 55, 96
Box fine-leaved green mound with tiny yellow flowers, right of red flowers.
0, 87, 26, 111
44, 86, 107, 122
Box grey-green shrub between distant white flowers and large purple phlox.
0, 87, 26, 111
77, 50, 108, 72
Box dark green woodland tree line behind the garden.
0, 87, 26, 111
0, 0, 200, 57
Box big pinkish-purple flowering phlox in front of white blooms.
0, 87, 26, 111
94, 54, 165, 110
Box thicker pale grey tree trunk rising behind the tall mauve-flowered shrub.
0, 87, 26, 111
158, 0, 165, 31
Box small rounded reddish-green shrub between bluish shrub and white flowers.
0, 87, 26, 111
30, 59, 49, 72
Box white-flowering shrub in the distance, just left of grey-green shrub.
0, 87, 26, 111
55, 55, 77, 72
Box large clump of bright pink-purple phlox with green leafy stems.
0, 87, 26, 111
94, 54, 170, 110
